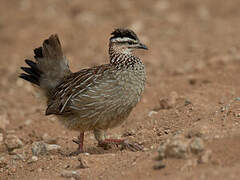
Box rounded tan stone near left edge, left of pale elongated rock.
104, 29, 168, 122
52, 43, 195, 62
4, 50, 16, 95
5, 134, 23, 151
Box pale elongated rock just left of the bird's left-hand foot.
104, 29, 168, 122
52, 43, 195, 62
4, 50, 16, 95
32, 141, 61, 156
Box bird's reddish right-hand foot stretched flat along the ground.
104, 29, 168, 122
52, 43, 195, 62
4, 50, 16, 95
98, 139, 143, 152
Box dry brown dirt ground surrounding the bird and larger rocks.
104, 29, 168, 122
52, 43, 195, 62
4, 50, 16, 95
0, 0, 240, 180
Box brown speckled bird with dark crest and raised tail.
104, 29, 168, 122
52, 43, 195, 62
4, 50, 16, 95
19, 28, 148, 155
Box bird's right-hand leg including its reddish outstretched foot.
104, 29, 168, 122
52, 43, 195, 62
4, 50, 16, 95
94, 130, 143, 151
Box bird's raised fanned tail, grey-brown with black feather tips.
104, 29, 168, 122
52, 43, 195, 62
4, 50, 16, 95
19, 34, 71, 94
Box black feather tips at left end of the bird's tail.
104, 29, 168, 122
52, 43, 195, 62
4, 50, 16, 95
19, 59, 42, 86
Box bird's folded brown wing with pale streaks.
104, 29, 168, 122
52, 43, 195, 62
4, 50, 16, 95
46, 64, 118, 115
